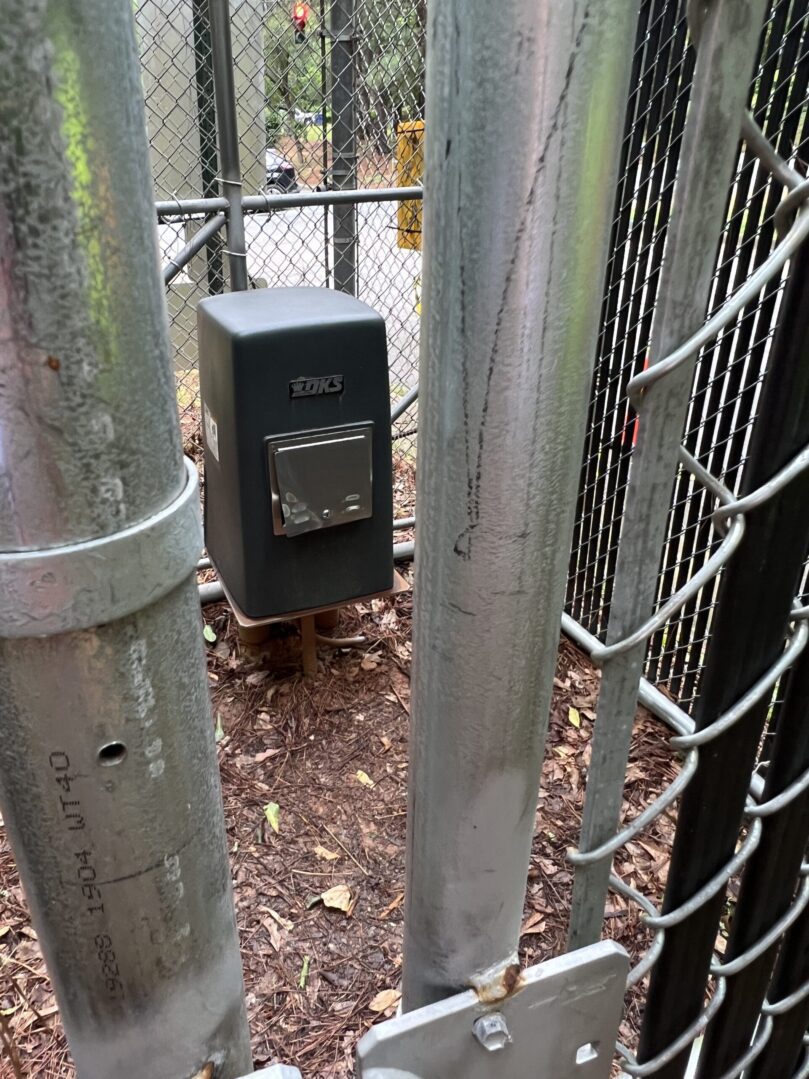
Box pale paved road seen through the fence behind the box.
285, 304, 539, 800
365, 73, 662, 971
160, 203, 422, 394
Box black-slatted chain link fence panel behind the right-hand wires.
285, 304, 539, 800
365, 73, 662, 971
567, 0, 809, 709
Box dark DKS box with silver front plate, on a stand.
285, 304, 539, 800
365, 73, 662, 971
197, 288, 393, 619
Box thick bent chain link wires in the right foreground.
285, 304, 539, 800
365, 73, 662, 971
567, 114, 809, 1079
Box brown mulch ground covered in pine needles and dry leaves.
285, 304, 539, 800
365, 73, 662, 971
0, 432, 675, 1079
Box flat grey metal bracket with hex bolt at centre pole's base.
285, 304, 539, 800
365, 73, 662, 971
357, 941, 629, 1079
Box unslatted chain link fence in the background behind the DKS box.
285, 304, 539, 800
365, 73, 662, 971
136, 0, 426, 492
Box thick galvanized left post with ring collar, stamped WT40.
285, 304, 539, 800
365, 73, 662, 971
0, 0, 250, 1079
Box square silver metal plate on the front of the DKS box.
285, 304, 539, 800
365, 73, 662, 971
266, 424, 373, 536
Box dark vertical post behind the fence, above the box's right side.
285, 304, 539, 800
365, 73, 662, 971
329, 0, 357, 296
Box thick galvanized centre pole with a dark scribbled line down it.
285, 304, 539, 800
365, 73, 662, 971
403, 0, 636, 1010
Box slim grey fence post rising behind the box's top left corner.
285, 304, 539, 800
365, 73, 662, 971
208, 0, 247, 292
